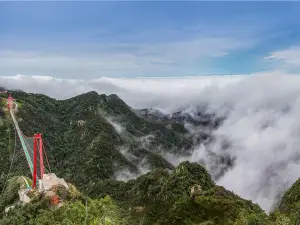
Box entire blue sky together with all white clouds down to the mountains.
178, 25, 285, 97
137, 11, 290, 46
4, 1, 300, 211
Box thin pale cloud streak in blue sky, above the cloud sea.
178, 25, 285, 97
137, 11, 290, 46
0, 37, 249, 78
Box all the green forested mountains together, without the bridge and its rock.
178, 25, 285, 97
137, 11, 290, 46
0, 91, 300, 225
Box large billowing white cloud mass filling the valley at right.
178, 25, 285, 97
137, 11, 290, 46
177, 75, 300, 211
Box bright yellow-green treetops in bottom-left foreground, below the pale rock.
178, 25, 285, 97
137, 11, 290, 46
0, 177, 125, 225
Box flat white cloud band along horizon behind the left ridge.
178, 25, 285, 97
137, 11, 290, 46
0, 75, 244, 112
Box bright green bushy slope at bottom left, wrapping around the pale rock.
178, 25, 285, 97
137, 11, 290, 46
0, 177, 126, 225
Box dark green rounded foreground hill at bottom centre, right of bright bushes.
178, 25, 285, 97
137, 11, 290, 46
90, 162, 263, 224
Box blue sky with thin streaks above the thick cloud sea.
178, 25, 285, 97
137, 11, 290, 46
0, 1, 300, 78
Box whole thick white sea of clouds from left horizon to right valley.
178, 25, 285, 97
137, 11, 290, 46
0, 72, 300, 211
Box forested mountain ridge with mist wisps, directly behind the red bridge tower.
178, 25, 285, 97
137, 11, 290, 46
2, 92, 193, 192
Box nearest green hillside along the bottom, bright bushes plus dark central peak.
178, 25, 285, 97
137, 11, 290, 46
0, 162, 267, 225
